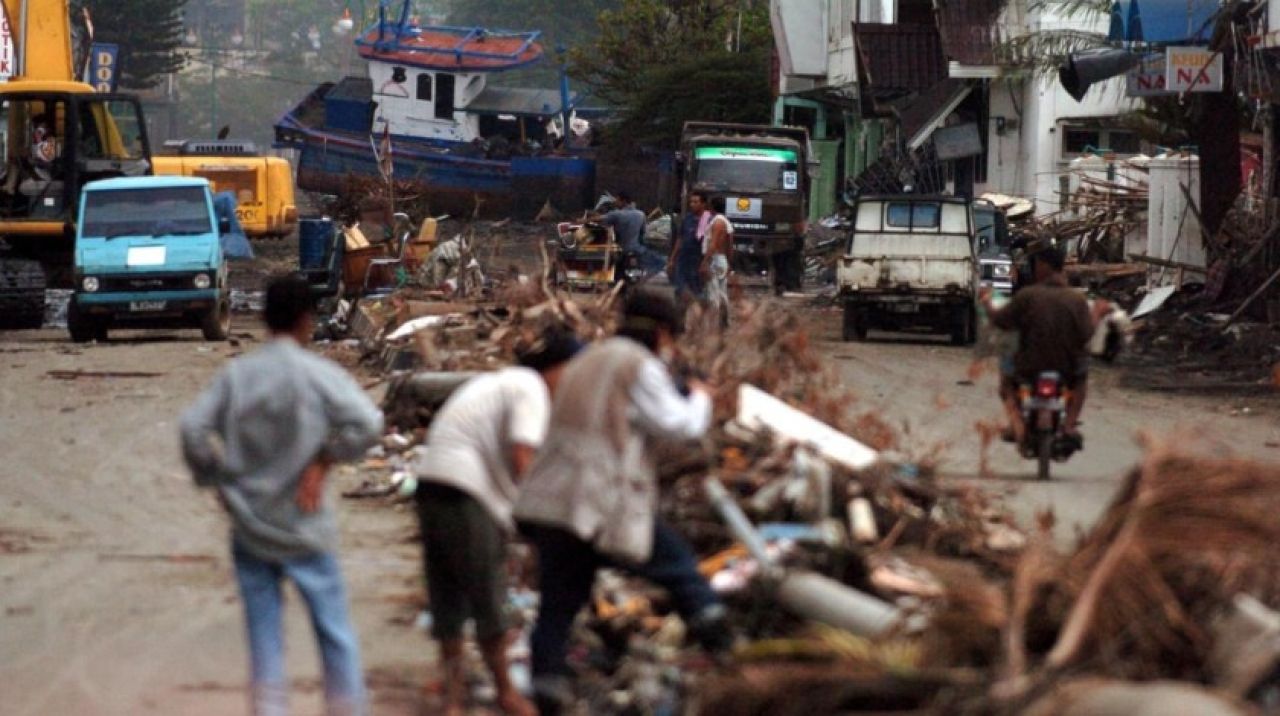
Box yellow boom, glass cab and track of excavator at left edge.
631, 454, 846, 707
0, 0, 151, 328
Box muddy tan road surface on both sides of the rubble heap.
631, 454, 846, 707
0, 313, 1280, 716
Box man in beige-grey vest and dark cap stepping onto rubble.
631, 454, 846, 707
515, 289, 731, 716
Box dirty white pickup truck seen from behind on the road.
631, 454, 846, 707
837, 195, 980, 345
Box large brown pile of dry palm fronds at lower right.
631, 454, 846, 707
1002, 443, 1280, 696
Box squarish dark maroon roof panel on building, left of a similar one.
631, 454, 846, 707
854, 23, 947, 97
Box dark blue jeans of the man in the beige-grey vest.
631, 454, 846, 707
521, 520, 723, 688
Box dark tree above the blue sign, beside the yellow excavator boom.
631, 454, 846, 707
72, 0, 187, 90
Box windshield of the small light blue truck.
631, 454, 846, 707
81, 187, 212, 238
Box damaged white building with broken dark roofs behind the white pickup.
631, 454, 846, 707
771, 0, 1139, 213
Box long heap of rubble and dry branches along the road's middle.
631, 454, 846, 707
317, 224, 1280, 715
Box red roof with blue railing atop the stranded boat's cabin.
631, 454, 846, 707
356, 23, 543, 72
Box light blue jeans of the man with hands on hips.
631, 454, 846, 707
232, 543, 365, 716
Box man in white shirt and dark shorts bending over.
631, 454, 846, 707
413, 330, 580, 716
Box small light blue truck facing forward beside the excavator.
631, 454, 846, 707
67, 177, 230, 342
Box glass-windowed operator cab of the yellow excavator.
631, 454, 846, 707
0, 91, 151, 222
